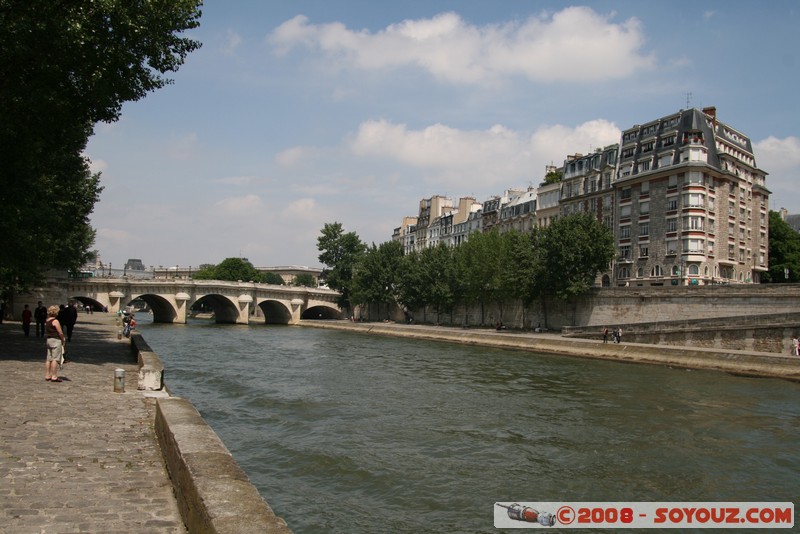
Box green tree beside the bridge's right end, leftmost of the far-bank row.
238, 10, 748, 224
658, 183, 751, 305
317, 222, 366, 309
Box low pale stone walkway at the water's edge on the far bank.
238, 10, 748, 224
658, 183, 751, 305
301, 320, 800, 381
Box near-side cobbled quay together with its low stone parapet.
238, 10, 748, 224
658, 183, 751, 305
0, 314, 290, 534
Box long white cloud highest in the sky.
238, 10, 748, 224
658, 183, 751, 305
270, 7, 654, 84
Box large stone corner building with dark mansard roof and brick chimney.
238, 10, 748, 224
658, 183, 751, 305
612, 107, 770, 286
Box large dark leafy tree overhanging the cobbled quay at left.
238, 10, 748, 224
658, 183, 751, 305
0, 0, 201, 291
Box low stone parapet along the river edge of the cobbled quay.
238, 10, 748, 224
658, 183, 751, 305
131, 333, 291, 534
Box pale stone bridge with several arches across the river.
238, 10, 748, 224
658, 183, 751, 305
61, 278, 342, 324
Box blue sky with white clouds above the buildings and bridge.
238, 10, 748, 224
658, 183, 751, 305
86, 0, 800, 267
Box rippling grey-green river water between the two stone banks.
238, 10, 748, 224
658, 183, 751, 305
139, 317, 800, 534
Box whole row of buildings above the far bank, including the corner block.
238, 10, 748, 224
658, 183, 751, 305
393, 107, 770, 286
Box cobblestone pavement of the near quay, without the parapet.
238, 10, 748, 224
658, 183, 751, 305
0, 313, 186, 534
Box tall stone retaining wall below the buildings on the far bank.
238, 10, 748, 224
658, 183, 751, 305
382, 284, 800, 353
